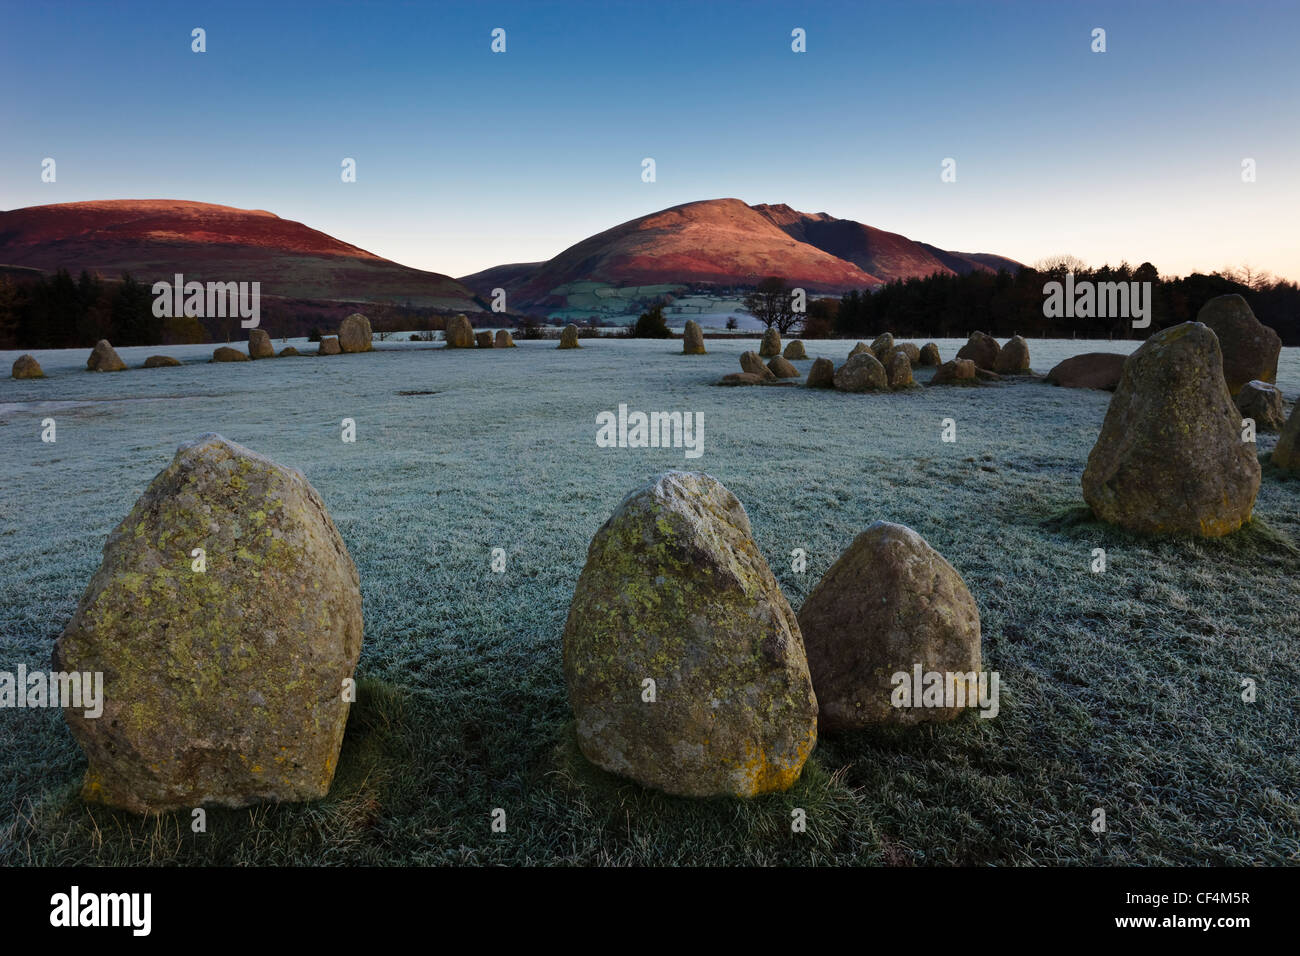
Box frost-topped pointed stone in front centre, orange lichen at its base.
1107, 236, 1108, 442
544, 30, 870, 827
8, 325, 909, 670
564, 472, 816, 797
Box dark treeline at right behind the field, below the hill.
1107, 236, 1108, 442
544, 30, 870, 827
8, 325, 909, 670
832, 263, 1300, 346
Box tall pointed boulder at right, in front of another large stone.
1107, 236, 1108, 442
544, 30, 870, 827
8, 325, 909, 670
1083, 323, 1260, 537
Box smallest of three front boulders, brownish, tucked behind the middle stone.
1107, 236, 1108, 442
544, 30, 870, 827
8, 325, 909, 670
800, 522, 980, 731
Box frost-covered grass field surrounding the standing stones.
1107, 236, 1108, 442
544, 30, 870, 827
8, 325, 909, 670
0, 339, 1300, 864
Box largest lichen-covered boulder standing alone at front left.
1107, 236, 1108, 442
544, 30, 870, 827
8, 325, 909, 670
53, 434, 361, 813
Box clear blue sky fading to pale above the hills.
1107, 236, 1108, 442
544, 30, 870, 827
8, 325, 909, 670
0, 0, 1300, 278
